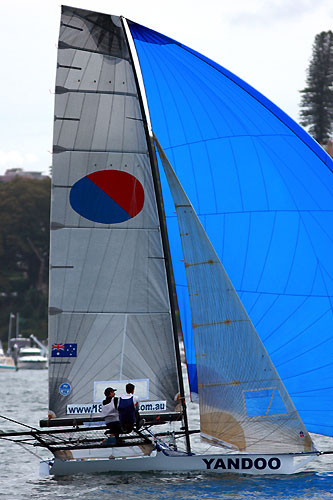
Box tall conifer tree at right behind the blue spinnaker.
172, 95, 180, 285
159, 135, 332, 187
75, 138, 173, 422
300, 31, 333, 144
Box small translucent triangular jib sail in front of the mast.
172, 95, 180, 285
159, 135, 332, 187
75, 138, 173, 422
155, 138, 312, 453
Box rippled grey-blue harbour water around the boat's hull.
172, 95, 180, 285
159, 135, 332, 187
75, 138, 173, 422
0, 370, 333, 500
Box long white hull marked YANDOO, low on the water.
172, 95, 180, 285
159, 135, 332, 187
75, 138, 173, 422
40, 449, 316, 476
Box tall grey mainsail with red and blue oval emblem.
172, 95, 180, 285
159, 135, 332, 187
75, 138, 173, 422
49, 7, 179, 417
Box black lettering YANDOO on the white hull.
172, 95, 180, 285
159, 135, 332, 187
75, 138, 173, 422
202, 457, 281, 470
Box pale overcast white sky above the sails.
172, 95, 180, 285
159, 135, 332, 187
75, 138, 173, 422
0, 0, 333, 175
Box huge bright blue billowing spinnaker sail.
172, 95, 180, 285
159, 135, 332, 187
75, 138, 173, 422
130, 23, 333, 435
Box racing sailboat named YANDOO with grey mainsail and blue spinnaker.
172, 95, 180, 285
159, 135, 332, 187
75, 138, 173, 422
0, 6, 333, 475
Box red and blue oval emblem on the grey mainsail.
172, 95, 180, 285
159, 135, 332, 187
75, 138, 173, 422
69, 170, 145, 224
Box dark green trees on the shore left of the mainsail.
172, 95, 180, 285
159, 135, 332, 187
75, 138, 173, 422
0, 177, 50, 340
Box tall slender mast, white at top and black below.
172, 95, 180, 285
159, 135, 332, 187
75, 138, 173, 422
120, 16, 191, 453
